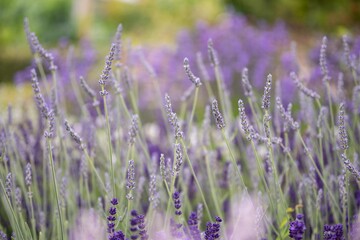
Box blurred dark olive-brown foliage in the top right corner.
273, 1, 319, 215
225, 0, 360, 32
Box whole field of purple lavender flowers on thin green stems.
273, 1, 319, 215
0, 10, 360, 240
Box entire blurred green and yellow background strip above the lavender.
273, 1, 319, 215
0, 0, 360, 106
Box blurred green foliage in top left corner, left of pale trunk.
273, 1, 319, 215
0, 0, 75, 46
